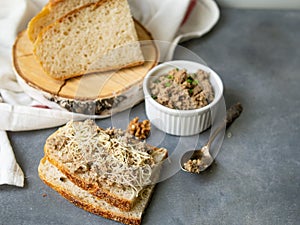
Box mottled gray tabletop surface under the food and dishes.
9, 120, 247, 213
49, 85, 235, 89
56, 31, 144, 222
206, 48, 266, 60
0, 9, 300, 225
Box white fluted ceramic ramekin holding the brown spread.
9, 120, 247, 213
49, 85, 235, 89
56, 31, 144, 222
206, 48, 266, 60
143, 60, 223, 136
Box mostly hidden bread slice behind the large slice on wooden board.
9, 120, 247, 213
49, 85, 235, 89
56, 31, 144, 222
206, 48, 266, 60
27, 0, 99, 43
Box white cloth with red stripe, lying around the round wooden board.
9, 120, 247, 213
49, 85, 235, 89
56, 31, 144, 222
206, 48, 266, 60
0, 0, 219, 186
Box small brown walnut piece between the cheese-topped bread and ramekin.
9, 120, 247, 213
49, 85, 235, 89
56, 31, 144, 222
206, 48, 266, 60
127, 117, 151, 140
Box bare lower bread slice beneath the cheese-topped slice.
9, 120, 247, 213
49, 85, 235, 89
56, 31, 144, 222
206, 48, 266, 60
38, 158, 154, 225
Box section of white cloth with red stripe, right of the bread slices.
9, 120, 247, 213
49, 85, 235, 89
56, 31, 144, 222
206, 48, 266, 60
128, 0, 220, 61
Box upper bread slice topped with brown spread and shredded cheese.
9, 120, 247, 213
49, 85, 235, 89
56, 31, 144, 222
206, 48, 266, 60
44, 120, 167, 211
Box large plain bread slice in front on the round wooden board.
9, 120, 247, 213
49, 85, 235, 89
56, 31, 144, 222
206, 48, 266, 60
33, 0, 144, 80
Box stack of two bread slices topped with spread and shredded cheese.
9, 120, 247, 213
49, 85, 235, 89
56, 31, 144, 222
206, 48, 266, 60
39, 120, 167, 224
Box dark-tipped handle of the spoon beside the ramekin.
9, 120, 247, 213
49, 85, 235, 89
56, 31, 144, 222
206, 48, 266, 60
207, 102, 243, 147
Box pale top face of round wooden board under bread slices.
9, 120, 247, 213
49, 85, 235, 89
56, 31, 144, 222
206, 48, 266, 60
12, 22, 159, 114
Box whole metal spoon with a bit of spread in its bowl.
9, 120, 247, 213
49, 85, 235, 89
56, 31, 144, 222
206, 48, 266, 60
180, 103, 243, 173
